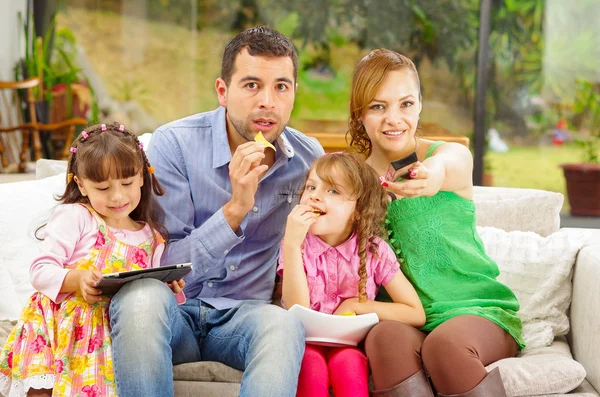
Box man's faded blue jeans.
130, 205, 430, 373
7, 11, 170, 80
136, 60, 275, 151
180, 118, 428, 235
109, 279, 304, 397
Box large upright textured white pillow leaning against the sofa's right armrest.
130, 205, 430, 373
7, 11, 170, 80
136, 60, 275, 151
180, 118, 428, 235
477, 227, 589, 349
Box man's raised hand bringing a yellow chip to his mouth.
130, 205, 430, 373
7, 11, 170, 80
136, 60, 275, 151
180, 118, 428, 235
223, 142, 269, 230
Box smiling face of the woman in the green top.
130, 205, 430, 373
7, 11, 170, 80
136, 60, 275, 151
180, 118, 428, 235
361, 69, 421, 158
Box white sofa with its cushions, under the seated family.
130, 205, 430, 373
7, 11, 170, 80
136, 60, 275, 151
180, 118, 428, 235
0, 160, 600, 397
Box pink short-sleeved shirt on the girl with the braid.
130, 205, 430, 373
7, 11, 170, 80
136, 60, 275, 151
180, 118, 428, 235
277, 234, 400, 314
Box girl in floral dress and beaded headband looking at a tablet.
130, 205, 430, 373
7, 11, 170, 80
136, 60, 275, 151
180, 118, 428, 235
0, 123, 185, 397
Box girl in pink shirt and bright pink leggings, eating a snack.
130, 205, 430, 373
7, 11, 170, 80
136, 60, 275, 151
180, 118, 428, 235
278, 153, 425, 397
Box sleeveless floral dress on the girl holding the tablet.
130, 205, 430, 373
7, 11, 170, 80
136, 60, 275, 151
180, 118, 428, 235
0, 207, 164, 397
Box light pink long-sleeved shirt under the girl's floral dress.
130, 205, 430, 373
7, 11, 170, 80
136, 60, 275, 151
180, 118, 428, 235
29, 204, 185, 303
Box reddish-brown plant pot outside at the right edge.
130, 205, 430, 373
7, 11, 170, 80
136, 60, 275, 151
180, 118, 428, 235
560, 164, 600, 216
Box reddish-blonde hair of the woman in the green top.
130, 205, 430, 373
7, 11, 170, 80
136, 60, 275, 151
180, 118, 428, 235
346, 48, 421, 157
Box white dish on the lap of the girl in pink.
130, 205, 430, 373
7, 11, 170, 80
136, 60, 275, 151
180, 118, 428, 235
289, 305, 379, 346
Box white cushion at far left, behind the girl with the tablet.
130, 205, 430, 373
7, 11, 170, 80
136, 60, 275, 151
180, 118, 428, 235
0, 173, 66, 312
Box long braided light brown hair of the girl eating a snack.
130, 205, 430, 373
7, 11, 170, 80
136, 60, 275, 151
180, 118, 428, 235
308, 152, 388, 302
